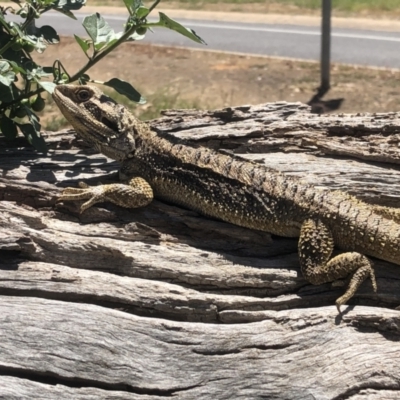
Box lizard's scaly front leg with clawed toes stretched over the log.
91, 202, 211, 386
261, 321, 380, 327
59, 178, 153, 213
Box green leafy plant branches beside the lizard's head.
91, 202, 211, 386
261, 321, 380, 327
0, 0, 204, 153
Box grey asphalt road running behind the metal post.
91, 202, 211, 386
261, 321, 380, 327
10, 13, 400, 68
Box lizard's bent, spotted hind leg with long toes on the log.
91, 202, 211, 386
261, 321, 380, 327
298, 219, 377, 312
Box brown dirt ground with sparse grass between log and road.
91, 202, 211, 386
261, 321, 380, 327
35, 37, 400, 126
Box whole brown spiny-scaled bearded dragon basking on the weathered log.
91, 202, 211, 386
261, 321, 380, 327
53, 85, 400, 312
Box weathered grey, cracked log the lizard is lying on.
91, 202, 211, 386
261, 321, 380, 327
0, 103, 400, 400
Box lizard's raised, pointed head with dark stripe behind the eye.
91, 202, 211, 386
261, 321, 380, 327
53, 85, 142, 161
